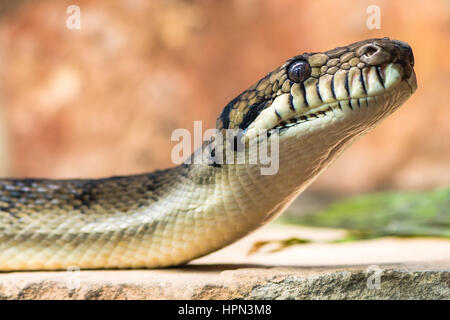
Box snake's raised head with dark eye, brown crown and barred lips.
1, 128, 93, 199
216, 38, 417, 138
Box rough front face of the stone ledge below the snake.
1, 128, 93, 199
0, 265, 450, 299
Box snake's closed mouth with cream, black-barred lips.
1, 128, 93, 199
247, 62, 417, 137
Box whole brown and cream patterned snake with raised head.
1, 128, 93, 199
0, 38, 417, 271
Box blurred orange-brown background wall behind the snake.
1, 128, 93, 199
0, 0, 450, 194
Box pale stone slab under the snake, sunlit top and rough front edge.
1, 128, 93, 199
0, 225, 450, 299
